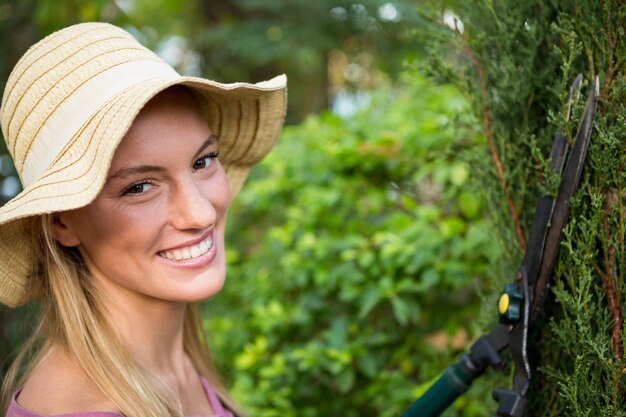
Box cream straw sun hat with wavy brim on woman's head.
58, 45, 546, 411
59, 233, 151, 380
0, 23, 286, 306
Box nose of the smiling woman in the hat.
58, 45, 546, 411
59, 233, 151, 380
170, 179, 217, 230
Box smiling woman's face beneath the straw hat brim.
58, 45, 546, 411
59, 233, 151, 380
54, 88, 230, 302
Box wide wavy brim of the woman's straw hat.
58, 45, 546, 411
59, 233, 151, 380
0, 75, 286, 307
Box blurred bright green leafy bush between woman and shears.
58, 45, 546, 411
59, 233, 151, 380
205, 74, 499, 417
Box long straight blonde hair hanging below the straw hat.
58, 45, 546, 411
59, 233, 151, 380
0, 215, 242, 417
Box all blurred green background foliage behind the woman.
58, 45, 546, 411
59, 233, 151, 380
0, 0, 510, 417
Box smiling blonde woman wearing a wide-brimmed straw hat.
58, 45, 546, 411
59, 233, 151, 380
0, 23, 286, 417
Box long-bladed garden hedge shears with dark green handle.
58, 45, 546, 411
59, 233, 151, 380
402, 75, 599, 417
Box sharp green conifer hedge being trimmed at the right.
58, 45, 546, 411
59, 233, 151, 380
425, 0, 626, 416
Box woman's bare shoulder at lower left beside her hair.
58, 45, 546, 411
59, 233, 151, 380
17, 350, 116, 416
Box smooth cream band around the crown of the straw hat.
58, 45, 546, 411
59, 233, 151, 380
20, 59, 180, 187
